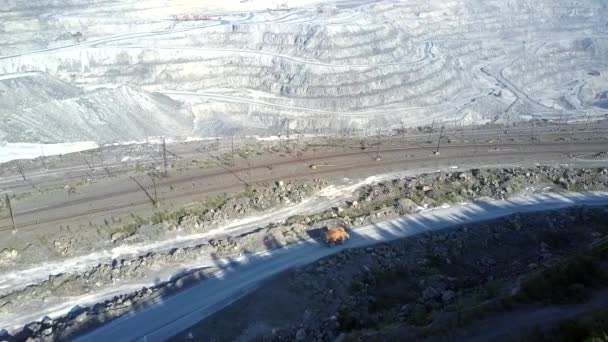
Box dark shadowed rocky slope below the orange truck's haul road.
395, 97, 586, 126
174, 207, 608, 341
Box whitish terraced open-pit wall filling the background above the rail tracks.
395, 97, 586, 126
0, 0, 608, 142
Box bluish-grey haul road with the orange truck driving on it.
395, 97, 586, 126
77, 192, 608, 341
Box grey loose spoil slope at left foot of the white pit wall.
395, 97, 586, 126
0, 74, 192, 143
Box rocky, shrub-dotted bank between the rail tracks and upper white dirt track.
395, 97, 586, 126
0, 179, 327, 268
